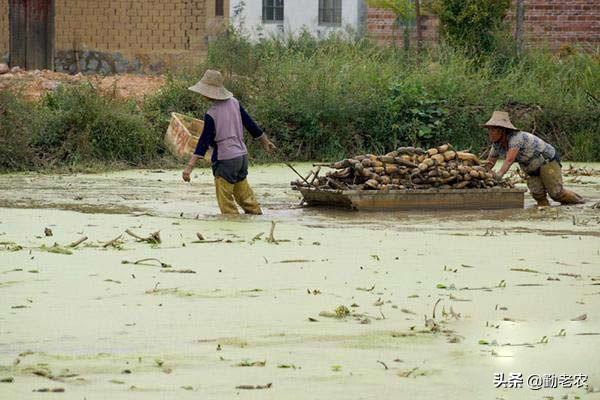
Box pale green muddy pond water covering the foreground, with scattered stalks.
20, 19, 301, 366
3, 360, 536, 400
0, 166, 600, 399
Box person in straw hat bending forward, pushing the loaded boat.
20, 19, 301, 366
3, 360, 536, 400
483, 111, 585, 207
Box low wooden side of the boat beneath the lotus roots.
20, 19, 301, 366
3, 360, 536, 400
301, 188, 525, 211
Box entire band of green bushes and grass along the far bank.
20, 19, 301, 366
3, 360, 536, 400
0, 31, 600, 171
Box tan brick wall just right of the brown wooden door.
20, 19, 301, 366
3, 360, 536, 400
55, 0, 207, 72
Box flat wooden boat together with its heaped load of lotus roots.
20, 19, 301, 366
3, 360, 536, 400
292, 144, 525, 210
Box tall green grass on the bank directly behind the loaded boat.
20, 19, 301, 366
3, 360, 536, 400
195, 32, 600, 161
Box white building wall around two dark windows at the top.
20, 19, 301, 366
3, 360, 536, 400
229, 0, 364, 39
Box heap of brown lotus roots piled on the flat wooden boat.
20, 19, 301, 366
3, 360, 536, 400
292, 144, 510, 191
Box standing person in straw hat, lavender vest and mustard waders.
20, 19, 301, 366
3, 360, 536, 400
183, 70, 276, 214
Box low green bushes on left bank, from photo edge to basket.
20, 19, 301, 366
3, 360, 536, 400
0, 84, 165, 171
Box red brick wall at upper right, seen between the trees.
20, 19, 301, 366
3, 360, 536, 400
367, 0, 600, 49
